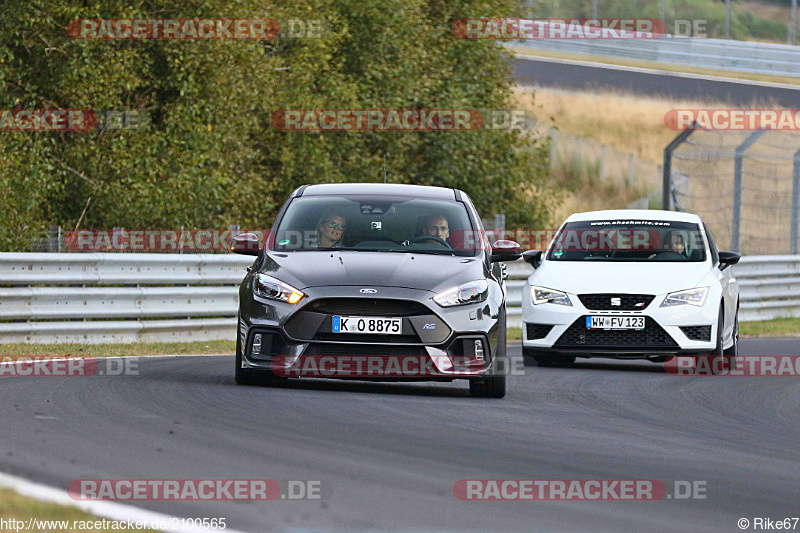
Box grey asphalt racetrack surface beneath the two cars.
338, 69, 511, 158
0, 338, 800, 531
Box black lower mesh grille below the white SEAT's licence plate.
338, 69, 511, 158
553, 316, 679, 351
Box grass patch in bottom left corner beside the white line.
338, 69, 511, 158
0, 489, 154, 533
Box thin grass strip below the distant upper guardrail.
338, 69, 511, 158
508, 45, 800, 85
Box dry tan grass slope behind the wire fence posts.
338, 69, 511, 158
514, 88, 796, 233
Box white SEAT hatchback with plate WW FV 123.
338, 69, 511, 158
522, 209, 740, 368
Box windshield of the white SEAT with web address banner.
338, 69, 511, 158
547, 220, 706, 263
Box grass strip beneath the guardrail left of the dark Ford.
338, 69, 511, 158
0, 341, 236, 357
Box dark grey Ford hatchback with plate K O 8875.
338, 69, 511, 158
231, 184, 520, 397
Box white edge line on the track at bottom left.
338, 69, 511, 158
0, 472, 248, 533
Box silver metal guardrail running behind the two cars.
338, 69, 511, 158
0, 253, 800, 344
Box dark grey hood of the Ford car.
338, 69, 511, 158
259, 251, 485, 292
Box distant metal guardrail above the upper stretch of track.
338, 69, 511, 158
513, 36, 800, 76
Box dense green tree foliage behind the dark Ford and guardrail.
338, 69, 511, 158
0, 0, 547, 251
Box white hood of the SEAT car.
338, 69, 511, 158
530, 261, 711, 294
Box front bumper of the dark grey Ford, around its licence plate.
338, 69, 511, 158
238, 287, 505, 381
